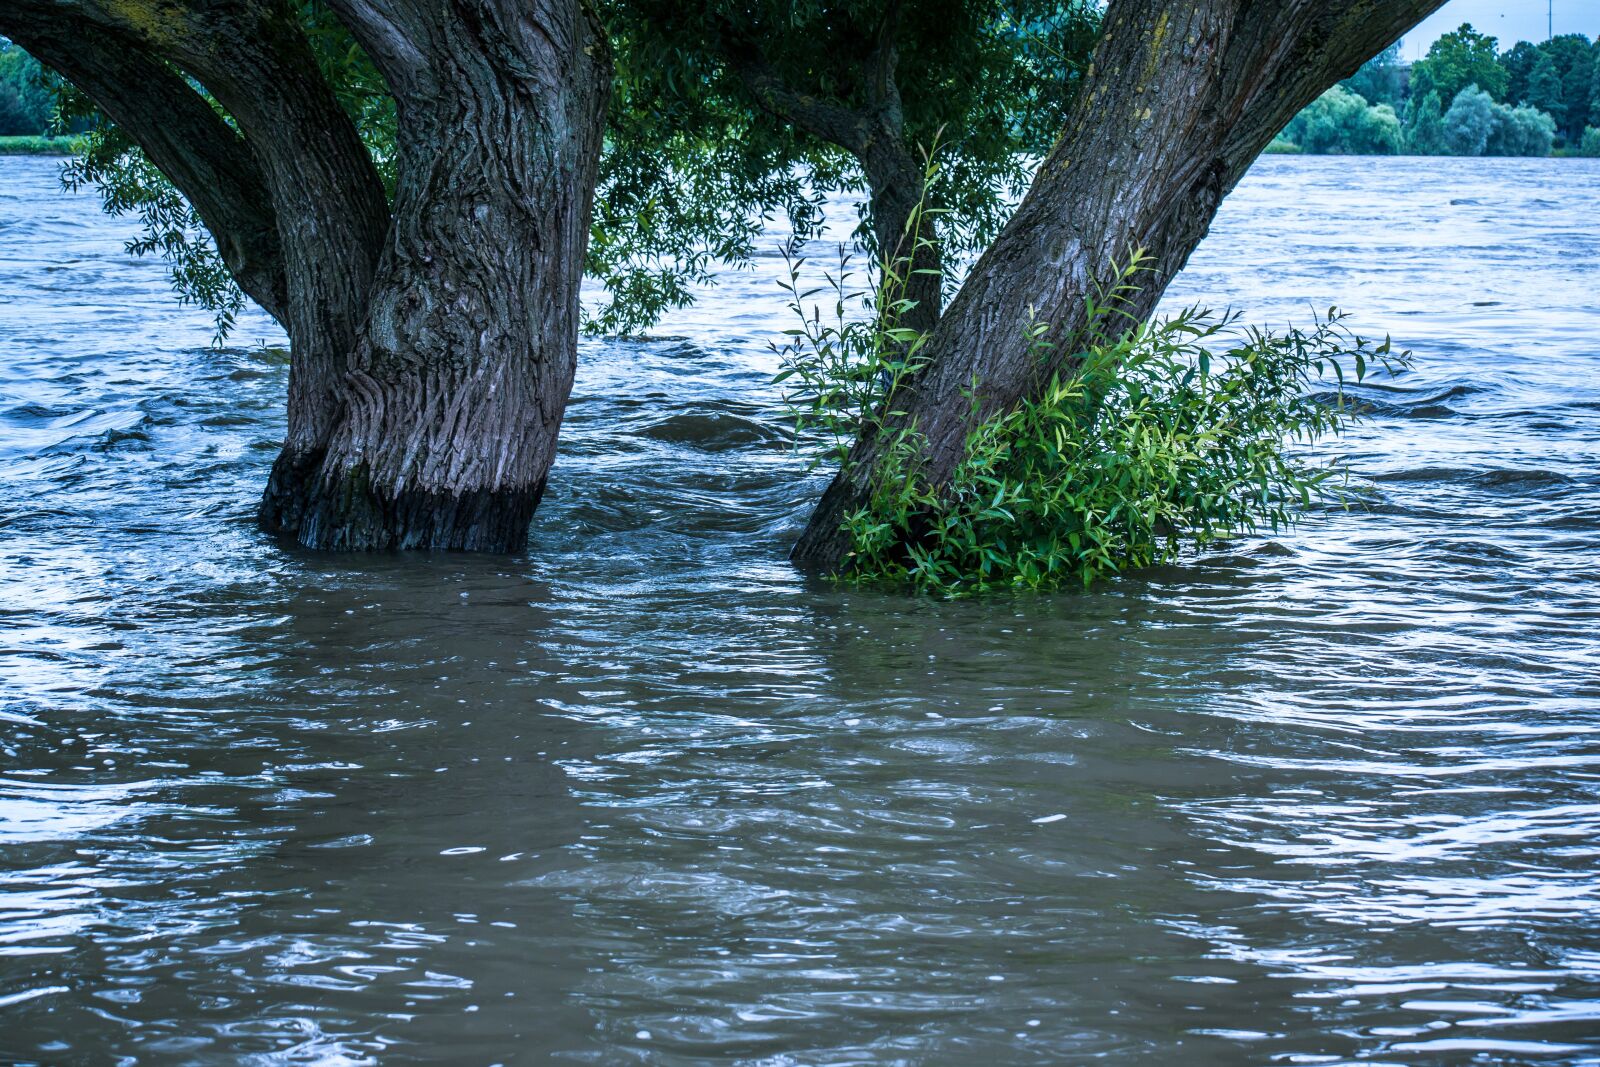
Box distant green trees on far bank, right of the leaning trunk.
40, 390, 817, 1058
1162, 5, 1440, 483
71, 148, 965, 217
1269, 24, 1600, 155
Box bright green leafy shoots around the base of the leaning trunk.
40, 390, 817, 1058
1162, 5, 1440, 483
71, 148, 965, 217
784, 244, 1408, 595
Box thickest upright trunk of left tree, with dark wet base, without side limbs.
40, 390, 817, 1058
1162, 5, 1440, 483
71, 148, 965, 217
281, 0, 610, 552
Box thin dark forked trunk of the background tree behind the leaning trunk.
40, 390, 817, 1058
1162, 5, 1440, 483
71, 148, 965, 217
720, 2, 944, 333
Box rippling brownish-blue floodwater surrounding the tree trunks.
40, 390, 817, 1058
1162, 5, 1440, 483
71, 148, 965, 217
0, 158, 1600, 1065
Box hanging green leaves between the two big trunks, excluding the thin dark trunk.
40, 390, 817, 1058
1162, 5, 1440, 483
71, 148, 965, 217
590, 0, 1099, 331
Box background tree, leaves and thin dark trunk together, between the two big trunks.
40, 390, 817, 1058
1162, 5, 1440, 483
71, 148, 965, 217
597, 0, 1098, 330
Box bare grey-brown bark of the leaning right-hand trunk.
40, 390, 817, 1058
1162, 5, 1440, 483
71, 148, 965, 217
794, 0, 1443, 568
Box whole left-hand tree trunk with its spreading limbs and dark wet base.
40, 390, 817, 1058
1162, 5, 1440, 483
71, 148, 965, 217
0, 0, 610, 552
